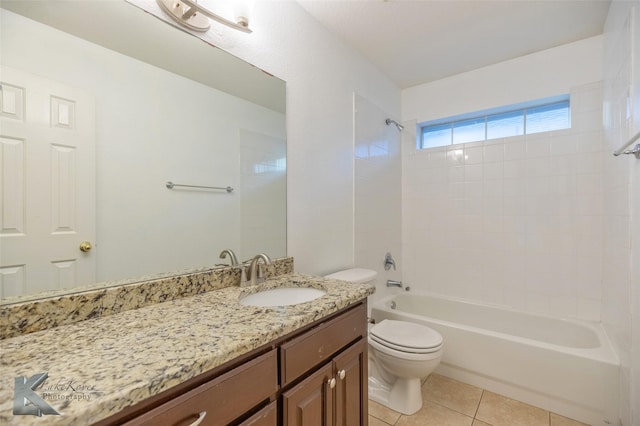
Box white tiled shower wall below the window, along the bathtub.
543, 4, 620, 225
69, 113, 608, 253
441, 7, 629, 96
402, 83, 603, 320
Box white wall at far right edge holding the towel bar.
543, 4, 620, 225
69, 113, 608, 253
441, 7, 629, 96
602, 0, 640, 426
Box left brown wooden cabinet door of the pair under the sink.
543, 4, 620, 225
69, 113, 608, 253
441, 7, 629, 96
282, 363, 335, 426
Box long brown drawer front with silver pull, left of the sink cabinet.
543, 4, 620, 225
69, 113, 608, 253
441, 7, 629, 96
126, 349, 278, 426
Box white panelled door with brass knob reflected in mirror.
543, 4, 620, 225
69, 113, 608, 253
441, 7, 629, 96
0, 67, 96, 298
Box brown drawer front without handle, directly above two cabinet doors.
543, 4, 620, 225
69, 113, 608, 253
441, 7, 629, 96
280, 305, 367, 386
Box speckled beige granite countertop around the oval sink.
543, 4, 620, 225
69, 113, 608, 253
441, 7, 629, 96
0, 273, 374, 425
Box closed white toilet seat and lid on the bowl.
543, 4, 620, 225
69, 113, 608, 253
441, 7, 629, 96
369, 319, 442, 354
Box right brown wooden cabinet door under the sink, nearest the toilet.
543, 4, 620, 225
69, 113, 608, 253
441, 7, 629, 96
333, 339, 368, 426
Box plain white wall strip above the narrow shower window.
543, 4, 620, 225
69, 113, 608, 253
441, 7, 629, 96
402, 36, 602, 123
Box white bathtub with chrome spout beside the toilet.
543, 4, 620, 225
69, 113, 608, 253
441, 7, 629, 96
371, 293, 619, 426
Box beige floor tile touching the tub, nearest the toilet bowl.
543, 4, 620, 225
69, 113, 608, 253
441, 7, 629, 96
422, 374, 482, 417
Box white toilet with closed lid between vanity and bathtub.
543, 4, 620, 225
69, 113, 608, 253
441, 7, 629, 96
325, 268, 443, 415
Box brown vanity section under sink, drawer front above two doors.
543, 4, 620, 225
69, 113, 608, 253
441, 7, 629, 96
280, 305, 368, 426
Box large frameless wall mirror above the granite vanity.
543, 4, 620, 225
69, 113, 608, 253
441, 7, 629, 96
0, 0, 286, 304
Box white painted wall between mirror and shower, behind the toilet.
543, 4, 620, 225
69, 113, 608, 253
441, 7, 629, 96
130, 0, 400, 274
